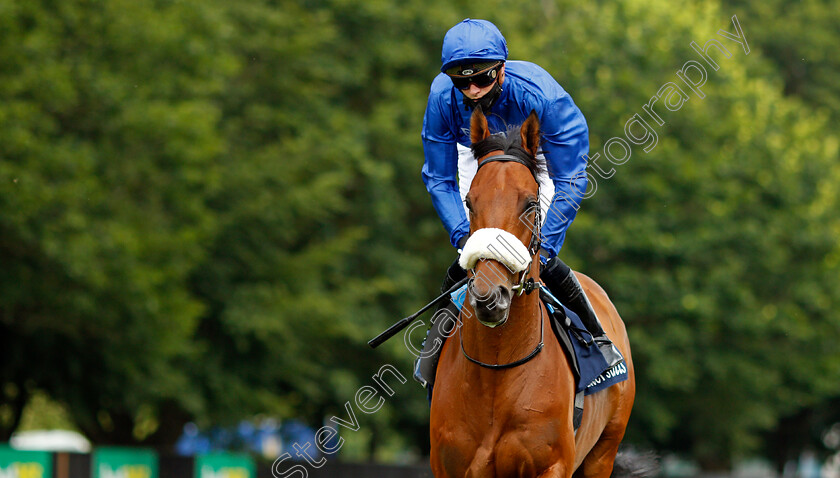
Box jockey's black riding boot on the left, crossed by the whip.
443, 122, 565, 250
414, 259, 467, 390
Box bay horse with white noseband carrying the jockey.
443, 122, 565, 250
430, 108, 636, 478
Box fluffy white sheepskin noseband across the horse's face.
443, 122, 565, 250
458, 227, 531, 273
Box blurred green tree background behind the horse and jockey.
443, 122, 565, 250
0, 0, 840, 477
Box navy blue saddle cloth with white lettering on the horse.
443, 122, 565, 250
451, 285, 627, 395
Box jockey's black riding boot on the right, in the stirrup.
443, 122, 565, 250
540, 257, 624, 367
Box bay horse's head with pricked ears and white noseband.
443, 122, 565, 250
461, 108, 540, 327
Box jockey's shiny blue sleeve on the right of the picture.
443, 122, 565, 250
538, 91, 589, 257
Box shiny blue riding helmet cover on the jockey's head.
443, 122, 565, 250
440, 18, 508, 72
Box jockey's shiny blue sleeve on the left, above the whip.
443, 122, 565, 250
422, 85, 470, 247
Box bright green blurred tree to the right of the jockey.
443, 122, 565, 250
498, 1, 840, 468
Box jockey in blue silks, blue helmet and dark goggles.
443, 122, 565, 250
414, 18, 623, 392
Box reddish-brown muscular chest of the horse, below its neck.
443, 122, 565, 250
430, 341, 574, 478
